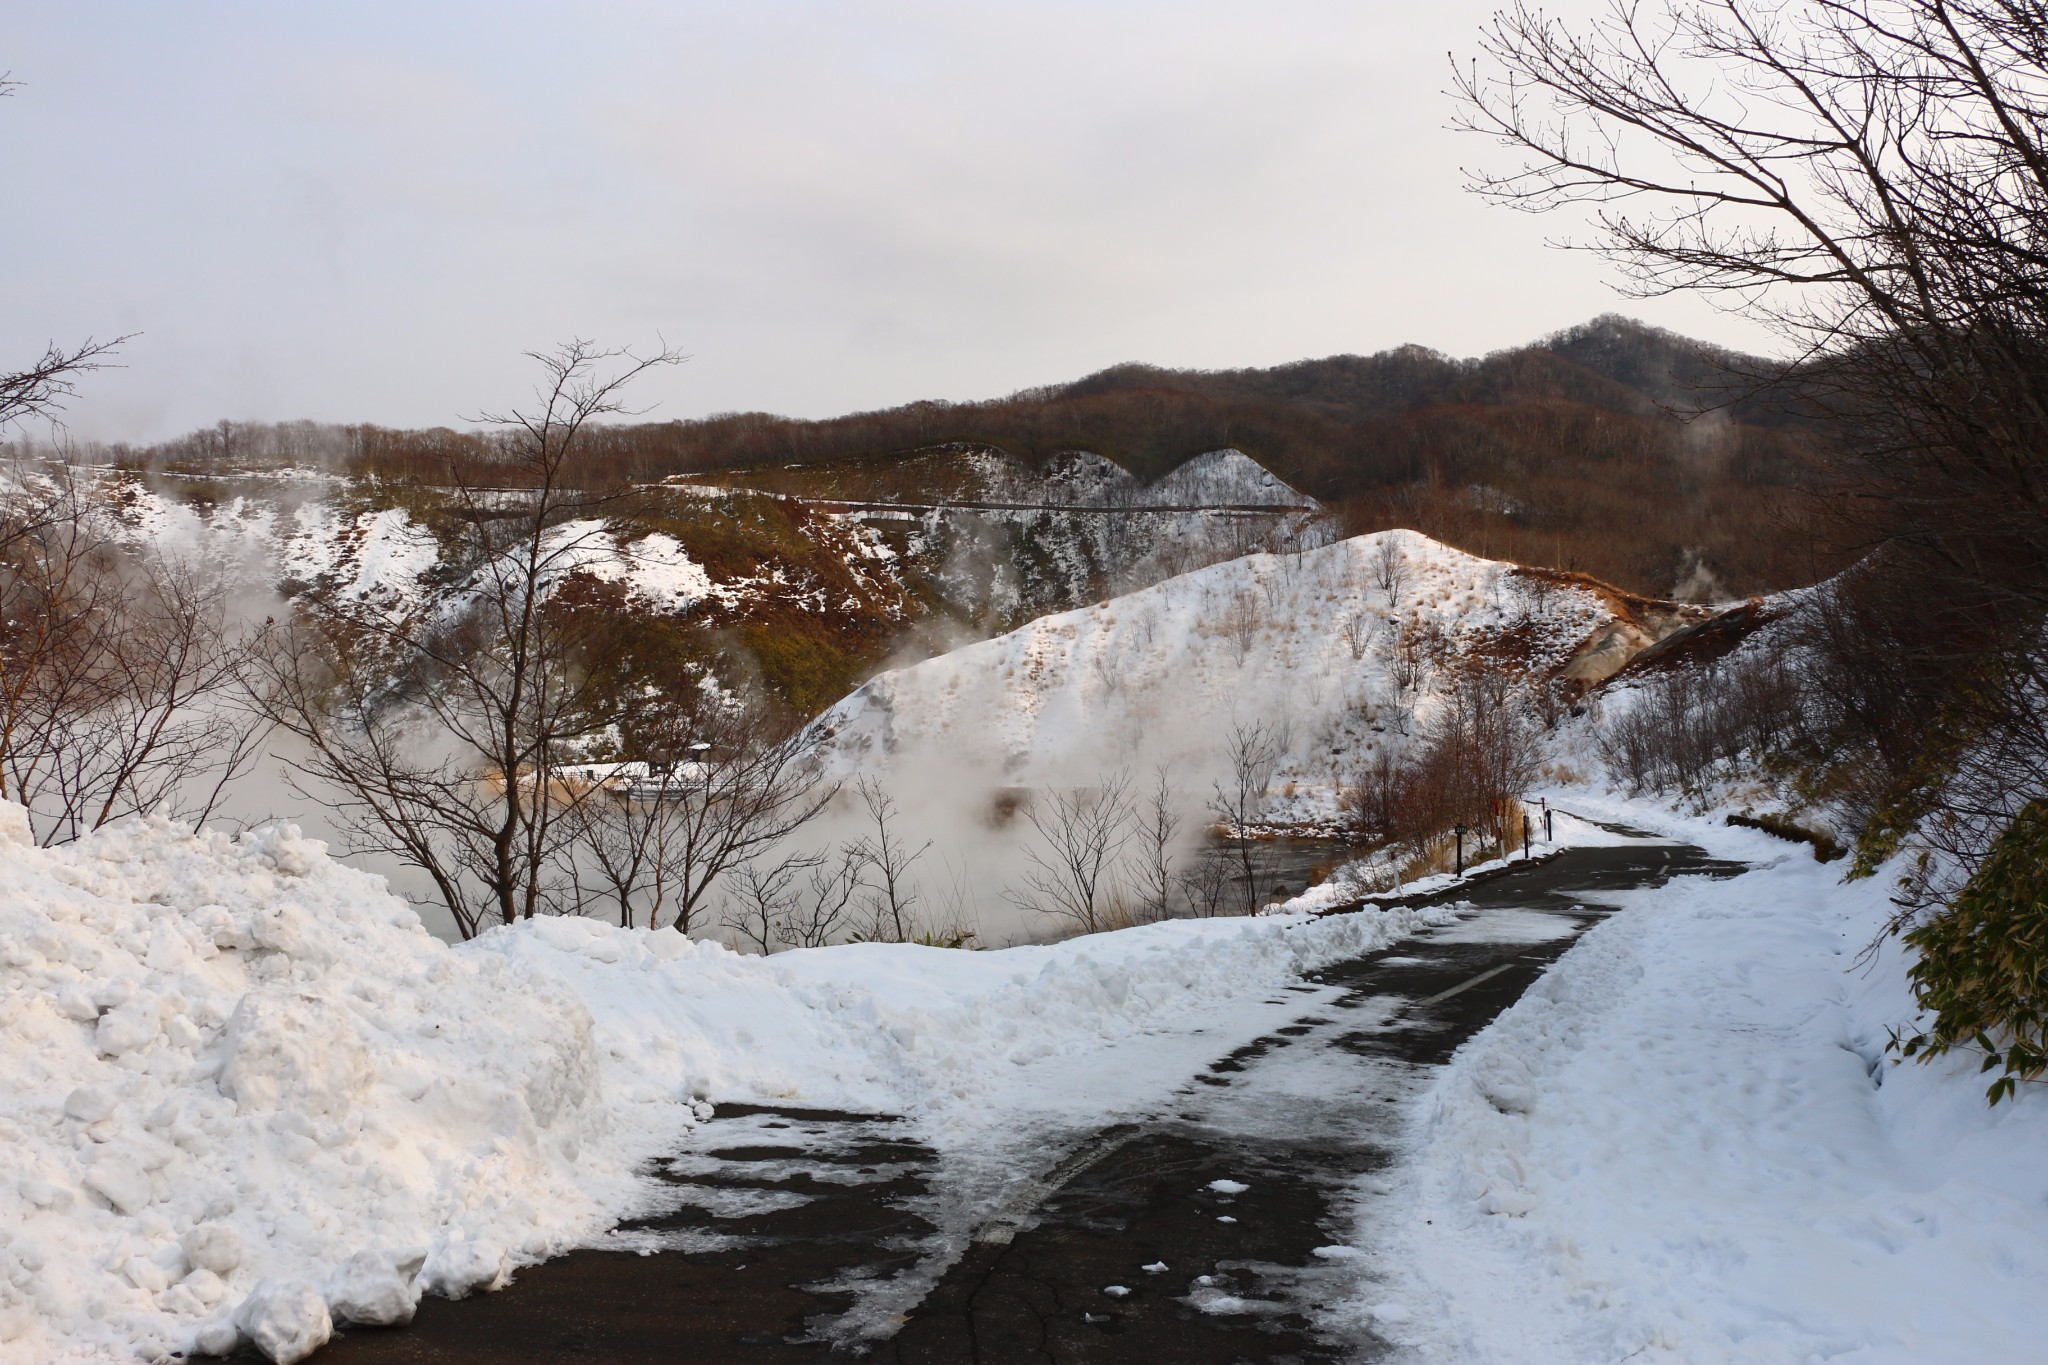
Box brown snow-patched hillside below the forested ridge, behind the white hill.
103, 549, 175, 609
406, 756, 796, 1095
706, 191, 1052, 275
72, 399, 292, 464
84, 458, 1331, 706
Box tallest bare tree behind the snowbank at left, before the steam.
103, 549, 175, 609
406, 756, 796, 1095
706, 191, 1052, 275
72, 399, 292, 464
254, 342, 682, 935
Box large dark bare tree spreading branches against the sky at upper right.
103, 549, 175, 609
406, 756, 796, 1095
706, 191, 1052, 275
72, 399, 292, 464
1456, 0, 2048, 929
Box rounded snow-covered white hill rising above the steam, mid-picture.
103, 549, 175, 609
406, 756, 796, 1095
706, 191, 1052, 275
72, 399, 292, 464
817, 530, 1646, 814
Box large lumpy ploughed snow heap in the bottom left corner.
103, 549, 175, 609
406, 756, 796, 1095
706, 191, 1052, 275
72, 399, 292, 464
0, 806, 631, 1361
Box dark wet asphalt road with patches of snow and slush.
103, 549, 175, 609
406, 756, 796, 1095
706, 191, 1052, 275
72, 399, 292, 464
280, 843, 1743, 1365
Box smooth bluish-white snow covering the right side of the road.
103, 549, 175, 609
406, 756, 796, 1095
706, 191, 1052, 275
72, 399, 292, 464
1358, 808, 2048, 1365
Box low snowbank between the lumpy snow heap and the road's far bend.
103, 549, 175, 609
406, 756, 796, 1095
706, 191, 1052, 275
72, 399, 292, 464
471, 909, 1448, 1150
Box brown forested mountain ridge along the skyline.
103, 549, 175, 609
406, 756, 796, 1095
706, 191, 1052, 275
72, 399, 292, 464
83, 315, 1841, 598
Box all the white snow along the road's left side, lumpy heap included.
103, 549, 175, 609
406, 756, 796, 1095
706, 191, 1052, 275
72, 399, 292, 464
0, 806, 1440, 1365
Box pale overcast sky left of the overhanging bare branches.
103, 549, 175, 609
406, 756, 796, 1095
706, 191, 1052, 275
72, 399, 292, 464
0, 0, 1759, 440
